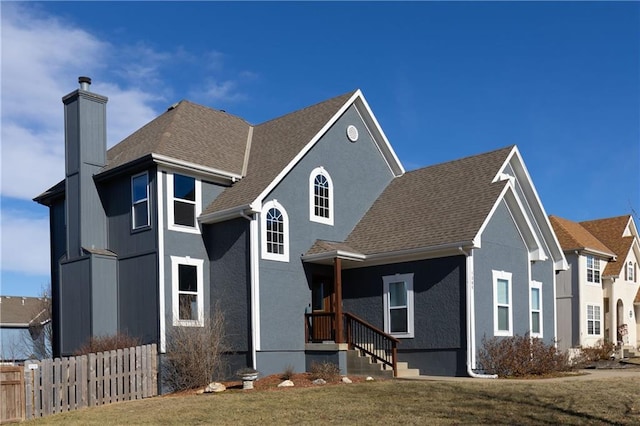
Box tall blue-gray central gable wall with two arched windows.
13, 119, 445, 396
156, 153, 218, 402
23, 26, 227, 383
258, 107, 393, 372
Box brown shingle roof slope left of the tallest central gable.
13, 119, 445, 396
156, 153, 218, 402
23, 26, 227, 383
202, 91, 355, 215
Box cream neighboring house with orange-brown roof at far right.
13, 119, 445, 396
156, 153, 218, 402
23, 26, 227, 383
550, 215, 640, 349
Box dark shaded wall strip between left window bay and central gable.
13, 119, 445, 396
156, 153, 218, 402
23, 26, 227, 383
203, 218, 252, 372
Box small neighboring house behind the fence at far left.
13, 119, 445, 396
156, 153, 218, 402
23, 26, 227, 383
0, 296, 51, 362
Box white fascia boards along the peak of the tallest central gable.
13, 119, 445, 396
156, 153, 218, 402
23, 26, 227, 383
251, 89, 404, 206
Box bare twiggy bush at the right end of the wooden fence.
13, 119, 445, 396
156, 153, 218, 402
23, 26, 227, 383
162, 309, 228, 391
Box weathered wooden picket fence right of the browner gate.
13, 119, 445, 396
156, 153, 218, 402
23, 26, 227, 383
24, 344, 158, 419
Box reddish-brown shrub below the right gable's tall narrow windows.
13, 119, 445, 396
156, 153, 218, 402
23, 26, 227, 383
478, 333, 569, 377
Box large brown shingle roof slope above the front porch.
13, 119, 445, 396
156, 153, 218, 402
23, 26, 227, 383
345, 146, 514, 254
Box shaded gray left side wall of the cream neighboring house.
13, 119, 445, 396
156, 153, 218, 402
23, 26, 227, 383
556, 253, 580, 350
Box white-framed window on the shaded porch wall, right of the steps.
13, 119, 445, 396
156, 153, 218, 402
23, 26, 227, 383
382, 274, 414, 338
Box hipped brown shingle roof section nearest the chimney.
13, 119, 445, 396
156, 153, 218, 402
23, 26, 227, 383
102, 101, 251, 175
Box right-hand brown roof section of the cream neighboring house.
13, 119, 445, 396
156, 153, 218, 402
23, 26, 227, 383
580, 215, 634, 276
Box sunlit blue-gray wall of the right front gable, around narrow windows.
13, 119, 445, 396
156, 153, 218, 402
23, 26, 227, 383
473, 202, 536, 352
